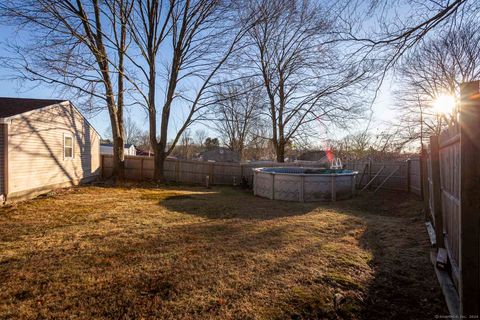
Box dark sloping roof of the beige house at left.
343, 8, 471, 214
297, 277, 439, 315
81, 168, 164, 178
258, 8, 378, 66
0, 97, 66, 118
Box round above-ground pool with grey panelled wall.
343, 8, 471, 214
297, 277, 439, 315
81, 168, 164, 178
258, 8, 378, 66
253, 167, 358, 202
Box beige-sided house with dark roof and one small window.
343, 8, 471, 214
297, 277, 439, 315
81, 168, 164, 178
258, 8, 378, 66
0, 97, 100, 202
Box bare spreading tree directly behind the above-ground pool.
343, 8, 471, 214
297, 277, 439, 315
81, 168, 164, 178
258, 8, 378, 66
241, 0, 368, 162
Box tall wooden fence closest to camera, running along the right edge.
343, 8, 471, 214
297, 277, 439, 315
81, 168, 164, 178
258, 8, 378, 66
422, 81, 480, 317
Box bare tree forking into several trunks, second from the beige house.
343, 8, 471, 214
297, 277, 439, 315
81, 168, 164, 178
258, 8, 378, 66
125, 0, 253, 181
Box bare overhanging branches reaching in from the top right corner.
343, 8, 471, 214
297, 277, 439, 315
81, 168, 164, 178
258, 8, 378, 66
337, 0, 470, 73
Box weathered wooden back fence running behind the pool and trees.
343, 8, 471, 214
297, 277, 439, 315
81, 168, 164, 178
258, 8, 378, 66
101, 155, 421, 194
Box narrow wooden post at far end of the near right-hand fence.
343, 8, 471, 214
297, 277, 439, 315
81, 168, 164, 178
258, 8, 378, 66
430, 136, 445, 248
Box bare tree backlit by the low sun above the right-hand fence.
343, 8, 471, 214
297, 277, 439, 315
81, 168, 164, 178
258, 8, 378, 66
396, 23, 480, 149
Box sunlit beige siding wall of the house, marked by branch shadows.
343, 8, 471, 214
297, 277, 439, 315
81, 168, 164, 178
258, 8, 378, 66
8, 104, 100, 198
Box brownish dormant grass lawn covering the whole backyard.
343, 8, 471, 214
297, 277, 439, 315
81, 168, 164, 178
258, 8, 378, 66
0, 185, 447, 319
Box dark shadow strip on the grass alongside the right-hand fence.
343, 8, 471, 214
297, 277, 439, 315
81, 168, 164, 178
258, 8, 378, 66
354, 192, 448, 319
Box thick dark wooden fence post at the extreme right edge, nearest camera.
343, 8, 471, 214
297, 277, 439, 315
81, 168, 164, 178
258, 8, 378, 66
459, 81, 480, 316
